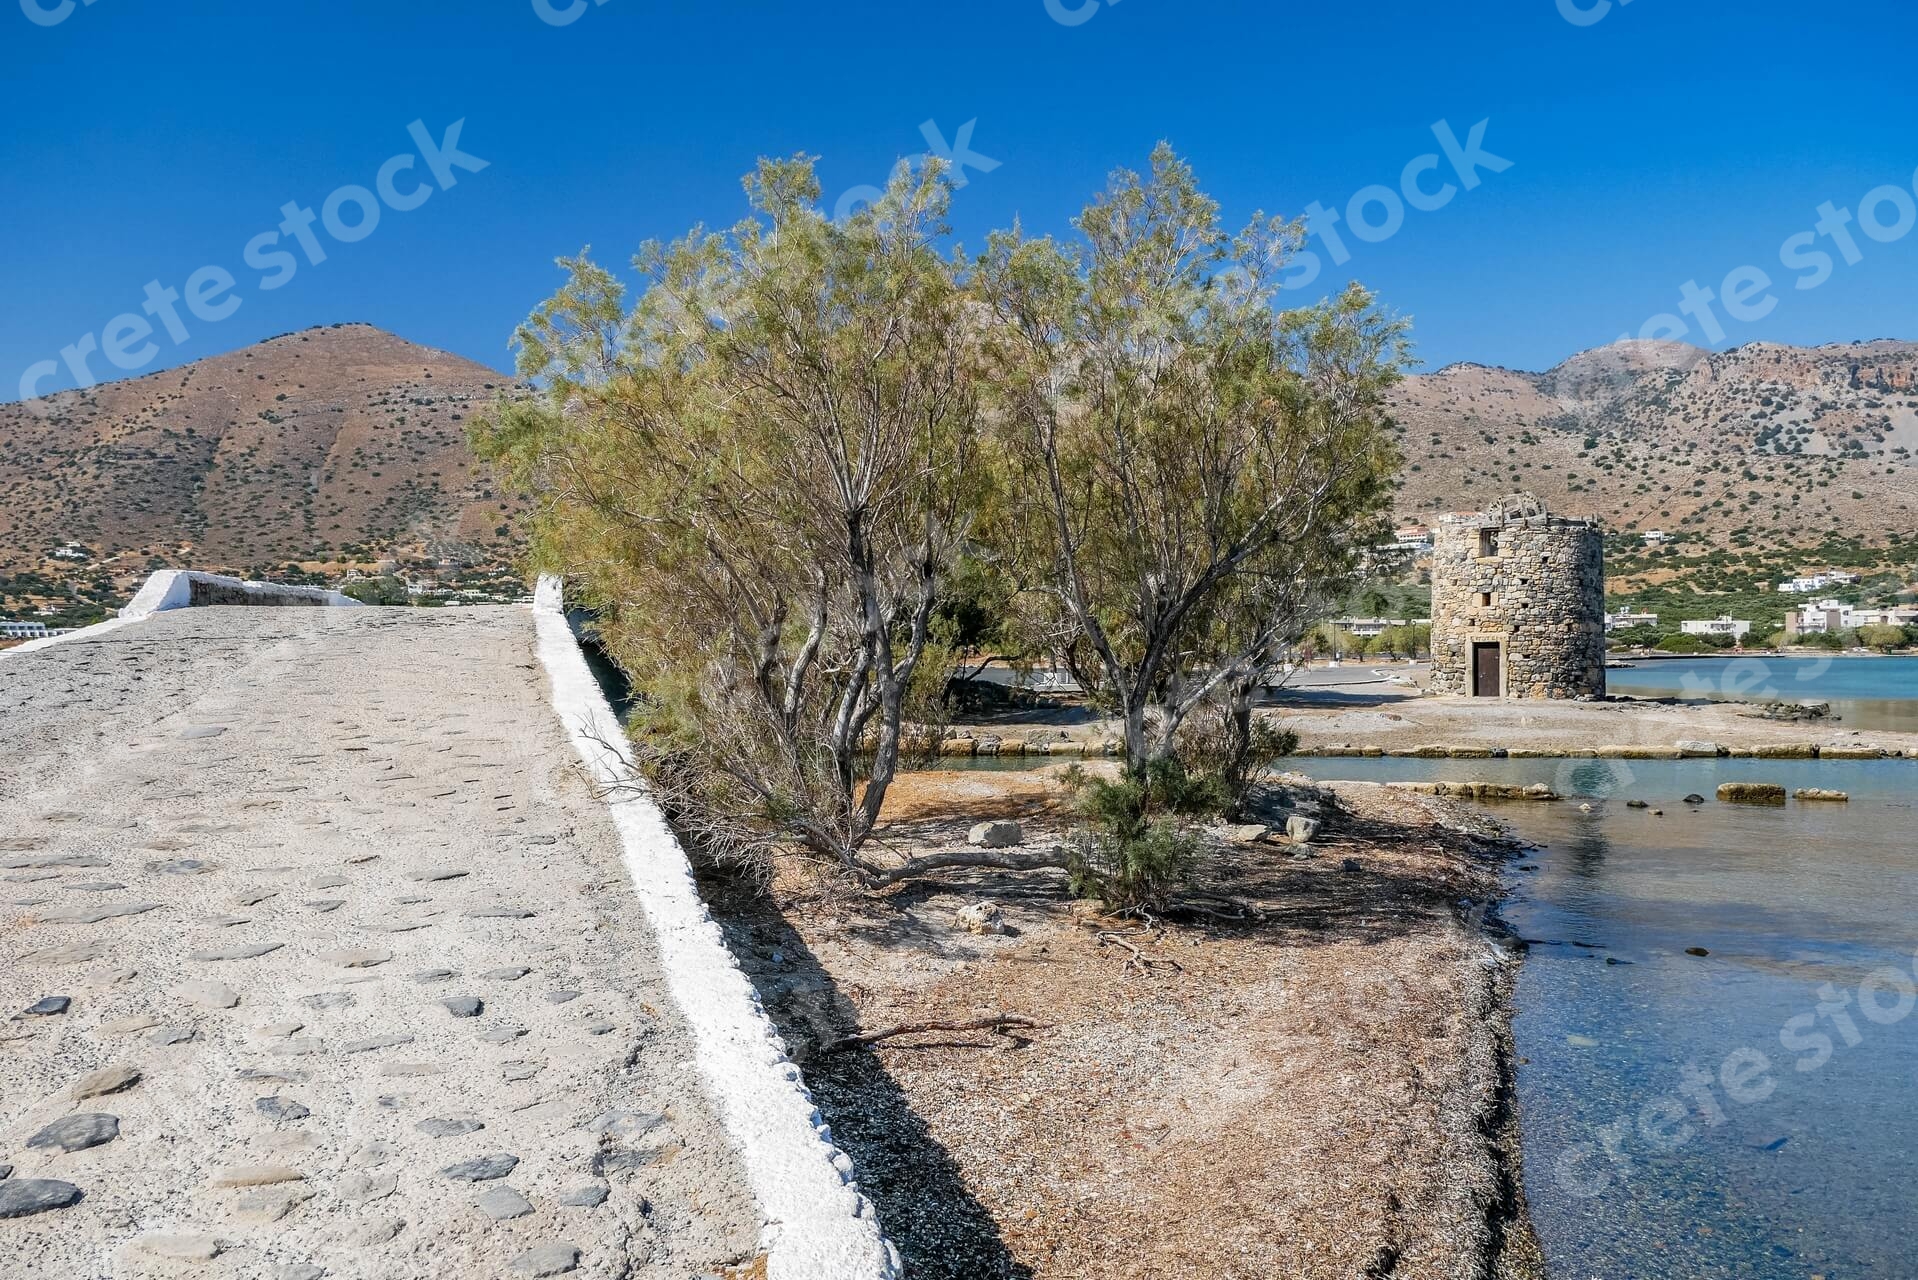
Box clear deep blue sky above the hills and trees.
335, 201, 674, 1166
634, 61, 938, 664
0, 0, 1918, 399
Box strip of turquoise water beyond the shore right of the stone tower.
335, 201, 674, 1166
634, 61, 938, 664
1605, 654, 1918, 736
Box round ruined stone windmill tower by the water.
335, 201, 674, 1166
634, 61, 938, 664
1431, 514, 1605, 699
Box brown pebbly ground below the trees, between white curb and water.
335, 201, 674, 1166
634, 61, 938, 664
719, 771, 1536, 1280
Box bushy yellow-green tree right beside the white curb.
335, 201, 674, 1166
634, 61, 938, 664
476, 155, 978, 875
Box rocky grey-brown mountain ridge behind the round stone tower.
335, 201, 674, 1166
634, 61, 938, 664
1394, 342, 1918, 547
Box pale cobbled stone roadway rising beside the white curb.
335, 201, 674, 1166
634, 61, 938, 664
0, 608, 761, 1280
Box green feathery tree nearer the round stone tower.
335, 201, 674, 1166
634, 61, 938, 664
976, 146, 1408, 777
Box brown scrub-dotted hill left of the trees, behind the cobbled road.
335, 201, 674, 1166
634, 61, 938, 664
0, 324, 518, 574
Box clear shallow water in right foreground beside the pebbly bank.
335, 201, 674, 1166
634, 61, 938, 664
1297, 760, 1918, 1280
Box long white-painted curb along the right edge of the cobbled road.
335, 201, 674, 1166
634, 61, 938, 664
533, 576, 901, 1280
